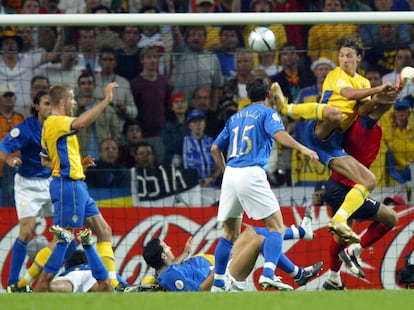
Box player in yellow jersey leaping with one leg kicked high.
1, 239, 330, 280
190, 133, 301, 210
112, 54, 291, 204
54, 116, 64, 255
271, 36, 398, 243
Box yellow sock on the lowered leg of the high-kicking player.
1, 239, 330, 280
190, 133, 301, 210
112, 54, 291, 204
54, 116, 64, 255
332, 184, 370, 222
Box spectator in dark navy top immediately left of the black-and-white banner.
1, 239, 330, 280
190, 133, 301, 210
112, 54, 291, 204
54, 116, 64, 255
86, 138, 131, 188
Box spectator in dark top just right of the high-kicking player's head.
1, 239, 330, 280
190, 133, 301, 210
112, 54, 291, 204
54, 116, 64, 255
364, 24, 408, 76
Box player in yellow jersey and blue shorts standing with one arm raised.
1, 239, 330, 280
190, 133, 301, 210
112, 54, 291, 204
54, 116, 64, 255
36, 83, 119, 292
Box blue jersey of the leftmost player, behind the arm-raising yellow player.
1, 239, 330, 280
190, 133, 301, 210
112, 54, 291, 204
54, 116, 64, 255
0, 116, 51, 178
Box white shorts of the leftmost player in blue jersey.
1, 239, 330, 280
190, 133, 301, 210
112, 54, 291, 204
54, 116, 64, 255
14, 173, 53, 219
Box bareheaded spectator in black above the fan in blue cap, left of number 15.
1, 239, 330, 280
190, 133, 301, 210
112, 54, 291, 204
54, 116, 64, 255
191, 86, 224, 138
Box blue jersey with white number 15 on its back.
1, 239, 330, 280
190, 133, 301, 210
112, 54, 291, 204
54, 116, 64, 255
214, 103, 285, 170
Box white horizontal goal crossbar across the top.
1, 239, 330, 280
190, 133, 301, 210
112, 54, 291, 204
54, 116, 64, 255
0, 11, 414, 26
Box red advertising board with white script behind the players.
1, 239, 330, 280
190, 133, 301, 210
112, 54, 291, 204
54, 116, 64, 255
0, 206, 414, 290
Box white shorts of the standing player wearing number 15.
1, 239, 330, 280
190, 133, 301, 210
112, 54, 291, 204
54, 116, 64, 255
217, 166, 280, 221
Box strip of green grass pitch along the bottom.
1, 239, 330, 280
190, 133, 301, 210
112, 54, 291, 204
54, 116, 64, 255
0, 290, 414, 310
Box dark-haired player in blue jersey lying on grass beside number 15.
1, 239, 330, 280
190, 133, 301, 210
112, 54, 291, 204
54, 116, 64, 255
143, 215, 322, 291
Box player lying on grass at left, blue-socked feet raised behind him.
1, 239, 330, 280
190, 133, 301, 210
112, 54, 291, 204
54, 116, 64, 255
35, 226, 114, 293
